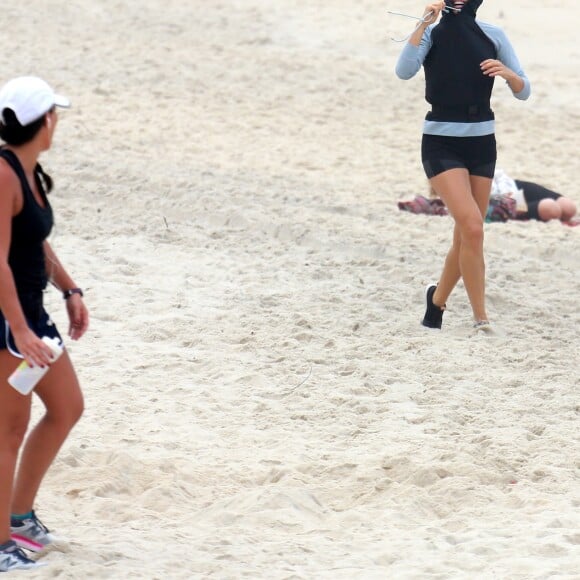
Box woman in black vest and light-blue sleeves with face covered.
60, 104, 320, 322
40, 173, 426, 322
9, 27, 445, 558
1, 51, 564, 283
396, 0, 531, 329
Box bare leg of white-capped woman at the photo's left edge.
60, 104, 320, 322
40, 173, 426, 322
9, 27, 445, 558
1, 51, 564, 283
0, 350, 32, 544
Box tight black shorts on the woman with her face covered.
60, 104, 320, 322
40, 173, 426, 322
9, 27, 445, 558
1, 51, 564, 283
421, 134, 497, 179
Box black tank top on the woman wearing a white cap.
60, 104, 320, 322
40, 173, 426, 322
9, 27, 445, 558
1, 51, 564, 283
0, 149, 54, 298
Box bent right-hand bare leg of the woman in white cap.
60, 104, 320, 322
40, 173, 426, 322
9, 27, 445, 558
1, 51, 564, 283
12, 350, 83, 514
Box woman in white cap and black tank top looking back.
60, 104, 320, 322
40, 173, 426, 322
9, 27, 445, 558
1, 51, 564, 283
0, 77, 89, 571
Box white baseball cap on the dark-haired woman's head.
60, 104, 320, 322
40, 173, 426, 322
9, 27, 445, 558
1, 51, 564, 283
0, 77, 70, 126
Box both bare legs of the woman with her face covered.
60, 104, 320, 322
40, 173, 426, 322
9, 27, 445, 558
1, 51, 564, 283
430, 169, 491, 321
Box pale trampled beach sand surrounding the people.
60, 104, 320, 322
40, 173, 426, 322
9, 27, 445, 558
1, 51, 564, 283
0, 0, 580, 580
